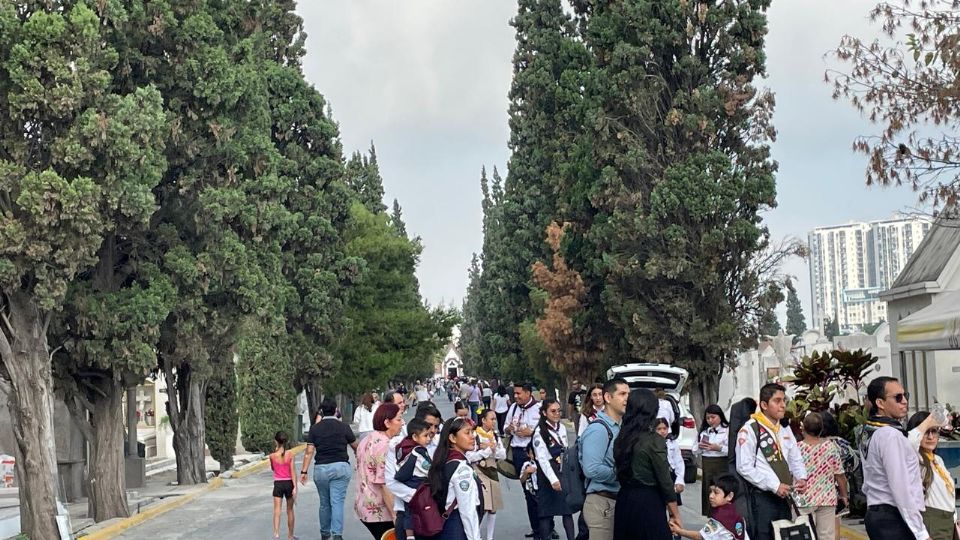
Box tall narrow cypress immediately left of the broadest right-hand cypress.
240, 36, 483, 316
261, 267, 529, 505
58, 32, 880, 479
483, 0, 588, 380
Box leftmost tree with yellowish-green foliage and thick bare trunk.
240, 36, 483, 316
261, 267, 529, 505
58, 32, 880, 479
0, 2, 165, 538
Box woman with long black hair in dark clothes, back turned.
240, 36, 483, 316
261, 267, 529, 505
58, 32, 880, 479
613, 388, 682, 540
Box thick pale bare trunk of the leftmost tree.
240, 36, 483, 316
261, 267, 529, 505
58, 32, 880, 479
0, 292, 60, 538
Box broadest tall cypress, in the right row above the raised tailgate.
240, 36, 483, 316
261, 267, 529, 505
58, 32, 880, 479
571, 0, 782, 414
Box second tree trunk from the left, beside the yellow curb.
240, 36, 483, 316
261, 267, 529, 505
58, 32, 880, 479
87, 379, 130, 522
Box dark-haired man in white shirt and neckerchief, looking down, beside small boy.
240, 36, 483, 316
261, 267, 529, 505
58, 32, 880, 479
737, 383, 807, 540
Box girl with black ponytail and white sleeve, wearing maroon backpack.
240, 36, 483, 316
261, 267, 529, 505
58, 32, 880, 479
427, 416, 483, 540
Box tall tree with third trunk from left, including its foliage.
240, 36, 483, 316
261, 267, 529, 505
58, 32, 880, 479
108, 0, 292, 484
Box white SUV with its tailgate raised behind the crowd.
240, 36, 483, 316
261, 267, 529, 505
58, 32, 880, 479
607, 364, 697, 484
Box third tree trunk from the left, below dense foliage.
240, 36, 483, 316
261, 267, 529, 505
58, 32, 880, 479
167, 366, 207, 486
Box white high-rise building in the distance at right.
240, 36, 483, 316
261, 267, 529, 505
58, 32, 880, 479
809, 215, 931, 329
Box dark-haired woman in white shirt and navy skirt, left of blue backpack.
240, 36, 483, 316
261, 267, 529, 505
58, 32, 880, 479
533, 398, 576, 540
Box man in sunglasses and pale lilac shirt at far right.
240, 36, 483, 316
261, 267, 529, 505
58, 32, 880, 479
858, 377, 930, 540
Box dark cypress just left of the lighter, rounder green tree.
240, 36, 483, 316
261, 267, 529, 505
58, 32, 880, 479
267, 30, 364, 418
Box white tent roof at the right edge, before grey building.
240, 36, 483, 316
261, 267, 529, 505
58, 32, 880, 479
897, 291, 960, 351
